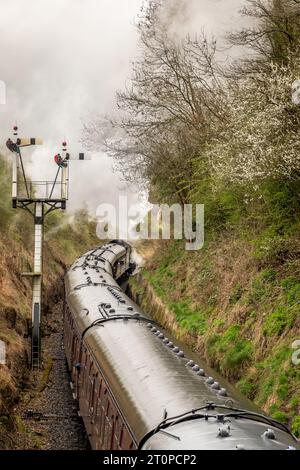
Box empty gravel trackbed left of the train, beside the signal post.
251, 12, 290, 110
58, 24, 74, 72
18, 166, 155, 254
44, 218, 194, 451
18, 301, 89, 450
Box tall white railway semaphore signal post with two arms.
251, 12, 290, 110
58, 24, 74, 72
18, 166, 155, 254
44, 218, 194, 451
6, 126, 86, 369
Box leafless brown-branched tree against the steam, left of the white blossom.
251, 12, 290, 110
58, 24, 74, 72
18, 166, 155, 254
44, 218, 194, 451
84, 0, 225, 202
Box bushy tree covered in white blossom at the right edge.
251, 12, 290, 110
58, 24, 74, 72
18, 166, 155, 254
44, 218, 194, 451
207, 60, 300, 183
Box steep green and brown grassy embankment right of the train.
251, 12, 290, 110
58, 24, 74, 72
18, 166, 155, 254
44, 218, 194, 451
133, 182, 300, 436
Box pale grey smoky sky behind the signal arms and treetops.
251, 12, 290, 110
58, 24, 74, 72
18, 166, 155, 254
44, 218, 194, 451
0, 0, 244, 216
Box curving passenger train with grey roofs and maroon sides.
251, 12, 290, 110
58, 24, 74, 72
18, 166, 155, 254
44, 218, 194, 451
64, 241, 297, 450
